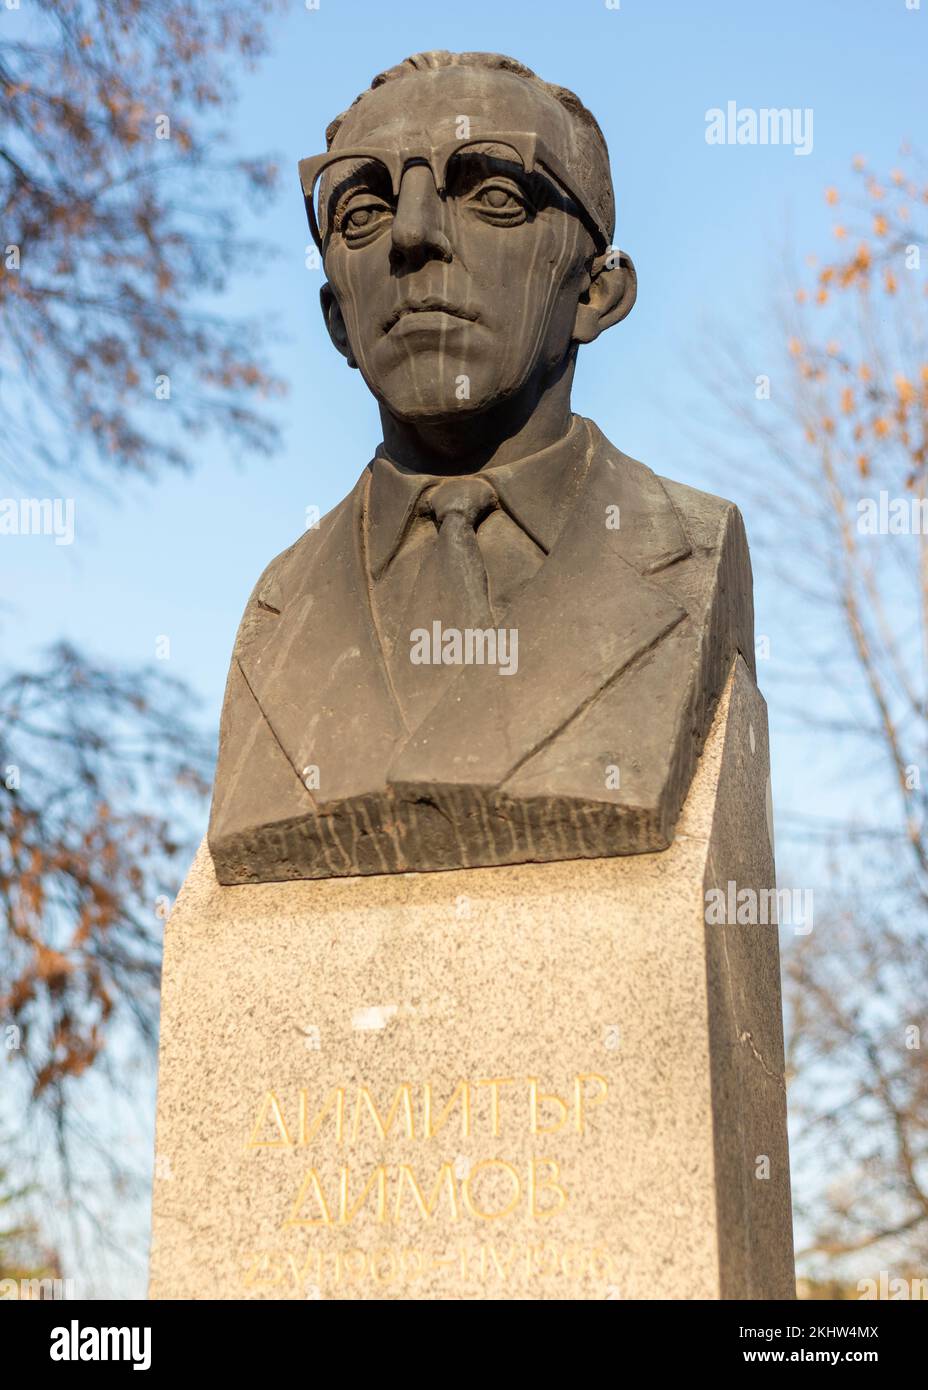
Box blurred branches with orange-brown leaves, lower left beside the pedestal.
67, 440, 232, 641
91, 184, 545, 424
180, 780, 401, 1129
0, 644, 210, 1106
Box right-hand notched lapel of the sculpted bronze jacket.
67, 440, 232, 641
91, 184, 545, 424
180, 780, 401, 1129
388, 421, 690, 790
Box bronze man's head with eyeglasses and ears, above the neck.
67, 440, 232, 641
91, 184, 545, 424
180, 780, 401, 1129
306, 53, 635, 421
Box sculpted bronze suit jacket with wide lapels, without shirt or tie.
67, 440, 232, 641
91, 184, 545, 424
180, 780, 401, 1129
208, 421, 754, 884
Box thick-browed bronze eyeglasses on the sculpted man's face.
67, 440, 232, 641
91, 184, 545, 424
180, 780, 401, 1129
300, 131, 610, 252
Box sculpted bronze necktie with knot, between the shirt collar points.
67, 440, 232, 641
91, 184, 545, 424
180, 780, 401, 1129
421, 473, 499, 630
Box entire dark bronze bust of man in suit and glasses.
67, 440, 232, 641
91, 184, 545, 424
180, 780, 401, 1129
208, 53, 754, 884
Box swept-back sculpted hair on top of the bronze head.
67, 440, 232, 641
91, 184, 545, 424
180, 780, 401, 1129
325, 49, 615, 244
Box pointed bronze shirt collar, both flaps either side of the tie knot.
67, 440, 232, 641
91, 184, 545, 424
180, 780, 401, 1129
367, 416, 590, 580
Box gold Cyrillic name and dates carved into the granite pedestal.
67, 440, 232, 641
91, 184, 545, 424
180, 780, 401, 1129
242, 1072, 613, 1297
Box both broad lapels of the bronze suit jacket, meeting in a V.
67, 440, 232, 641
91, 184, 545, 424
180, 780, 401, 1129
236, 421, 690, 810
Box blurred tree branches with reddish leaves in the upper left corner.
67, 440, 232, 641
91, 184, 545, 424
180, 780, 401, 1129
0, 0, 279, 485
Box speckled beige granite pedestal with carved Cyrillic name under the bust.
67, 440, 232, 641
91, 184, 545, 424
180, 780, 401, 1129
151, 660, 793, 1300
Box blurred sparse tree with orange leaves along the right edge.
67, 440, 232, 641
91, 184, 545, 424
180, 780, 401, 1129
702, 152, 928, 1282
